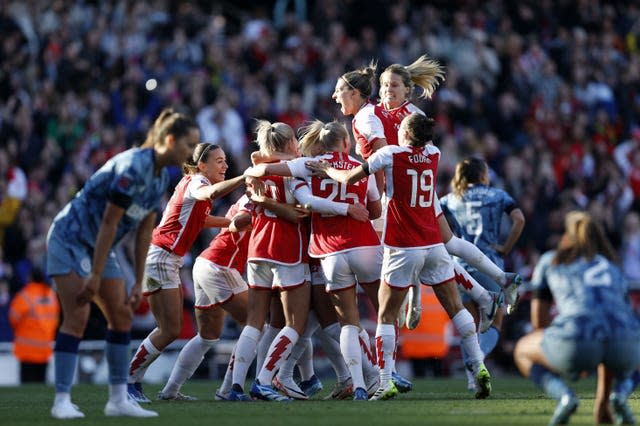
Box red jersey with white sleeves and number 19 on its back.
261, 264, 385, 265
368, 144, 442, 249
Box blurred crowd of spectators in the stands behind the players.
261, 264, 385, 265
0, 0, 640, 340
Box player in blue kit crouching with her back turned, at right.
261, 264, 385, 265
514, 211, 640, 426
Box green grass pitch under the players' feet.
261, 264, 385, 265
0, 377, 640, 426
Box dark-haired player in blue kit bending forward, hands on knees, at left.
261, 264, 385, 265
47, 109, 200, 419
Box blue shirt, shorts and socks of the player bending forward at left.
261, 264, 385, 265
47, 148, 169, 393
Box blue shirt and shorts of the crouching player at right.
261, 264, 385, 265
531, 251, 640, 379
